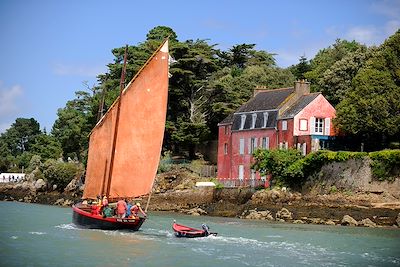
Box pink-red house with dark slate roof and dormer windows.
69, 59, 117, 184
218, 81, 335, 186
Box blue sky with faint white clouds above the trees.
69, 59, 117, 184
0, 0, 400, 133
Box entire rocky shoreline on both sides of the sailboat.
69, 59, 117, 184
0, 169, 400, 228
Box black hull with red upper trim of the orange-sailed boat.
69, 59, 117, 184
72, 203, 146, 231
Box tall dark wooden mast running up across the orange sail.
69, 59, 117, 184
105, 45, 128, 198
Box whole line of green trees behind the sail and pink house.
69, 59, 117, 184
0, 26, 400, 175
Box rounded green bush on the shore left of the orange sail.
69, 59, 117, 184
43, 159, 82, 191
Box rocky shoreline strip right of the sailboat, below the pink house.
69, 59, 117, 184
146, 189, 400, 228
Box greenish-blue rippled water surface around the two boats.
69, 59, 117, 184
0, 202, 400, 267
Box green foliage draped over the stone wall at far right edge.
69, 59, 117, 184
369, 150, 400, 181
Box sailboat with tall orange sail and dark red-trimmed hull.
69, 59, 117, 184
72, 39, 169, 231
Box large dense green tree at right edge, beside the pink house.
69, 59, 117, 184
334, 31, 400, 150
